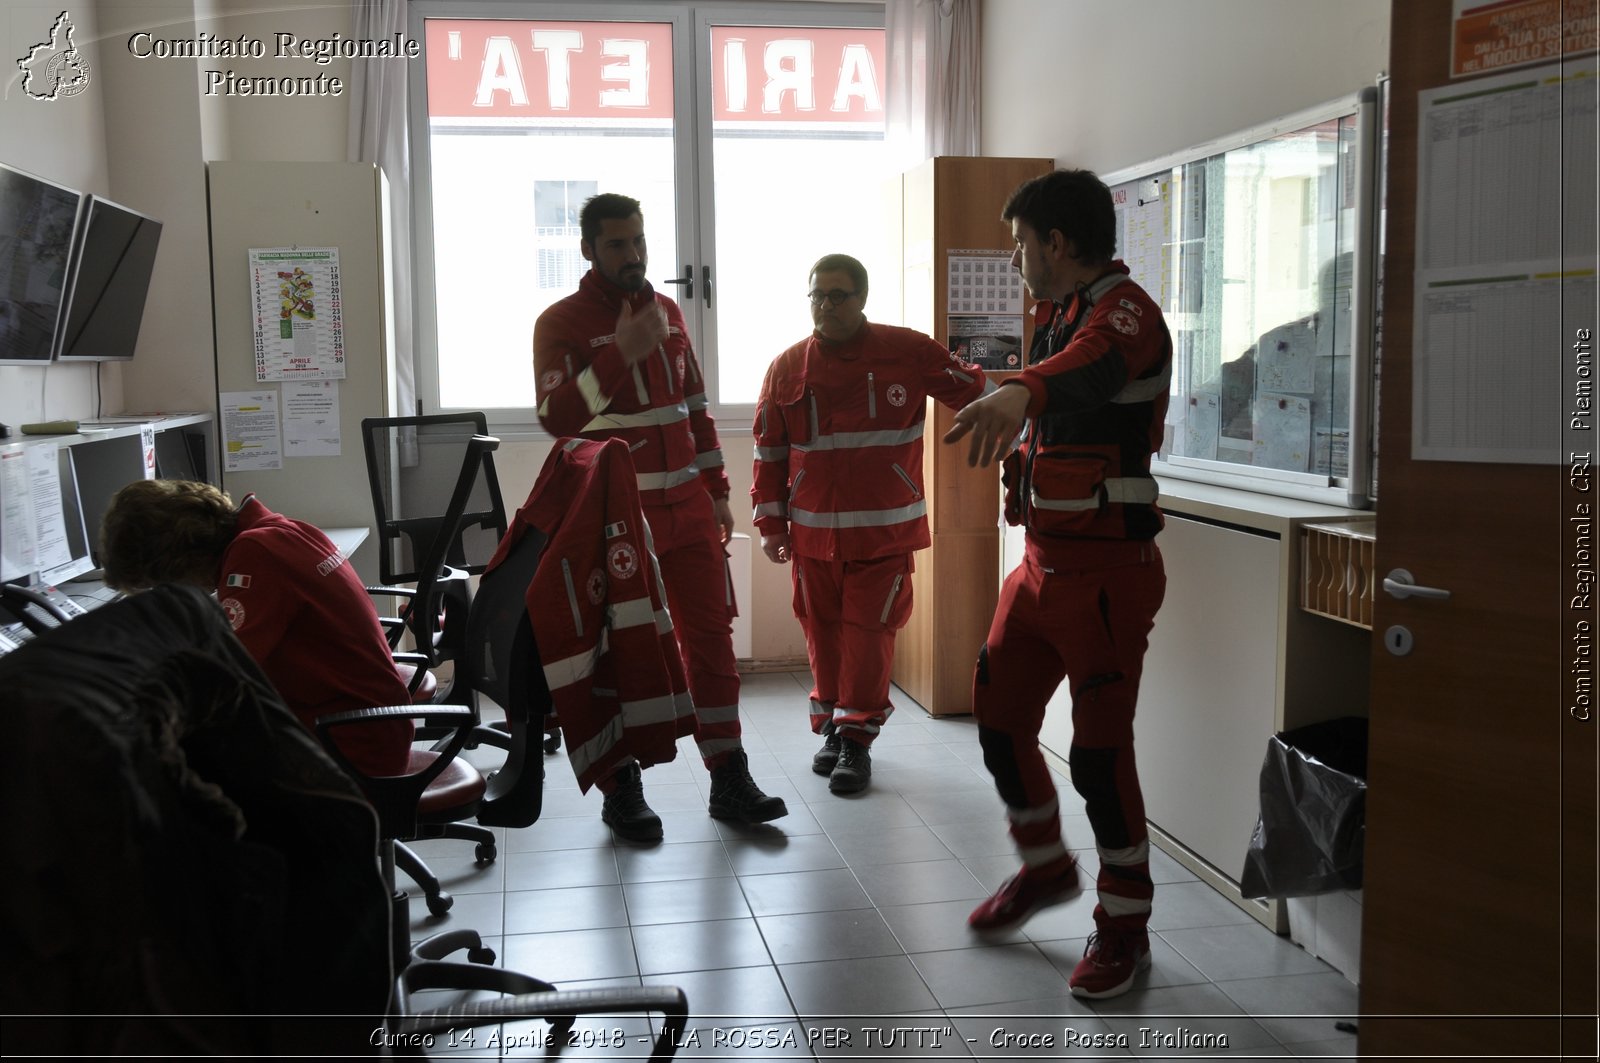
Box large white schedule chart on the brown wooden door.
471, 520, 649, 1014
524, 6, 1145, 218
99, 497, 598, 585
1411, 61, 1597, 463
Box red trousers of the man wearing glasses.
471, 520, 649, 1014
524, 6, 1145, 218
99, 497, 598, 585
794, 554, 912, 746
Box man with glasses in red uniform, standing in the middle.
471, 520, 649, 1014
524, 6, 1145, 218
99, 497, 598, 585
750, 255, 994, 794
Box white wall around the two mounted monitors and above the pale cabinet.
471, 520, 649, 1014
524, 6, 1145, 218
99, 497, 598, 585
0, 0, 350, 426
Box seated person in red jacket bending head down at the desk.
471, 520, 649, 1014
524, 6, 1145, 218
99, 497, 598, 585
101, 480, 413, 775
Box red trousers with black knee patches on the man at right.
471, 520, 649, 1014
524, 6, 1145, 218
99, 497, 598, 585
973, 538, 1166, 930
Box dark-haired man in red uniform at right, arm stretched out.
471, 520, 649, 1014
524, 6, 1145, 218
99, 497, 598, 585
946, 170, 1173, 997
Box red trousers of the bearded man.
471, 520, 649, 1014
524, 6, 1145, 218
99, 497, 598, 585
645, 491, 741, 768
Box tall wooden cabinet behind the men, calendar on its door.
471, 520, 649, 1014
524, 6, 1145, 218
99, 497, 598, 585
874, 157, 1054, 716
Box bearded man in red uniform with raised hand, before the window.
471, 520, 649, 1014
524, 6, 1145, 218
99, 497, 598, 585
533, 192, 789, 842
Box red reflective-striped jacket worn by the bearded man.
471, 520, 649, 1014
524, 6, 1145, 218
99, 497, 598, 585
533, 269, 728, 506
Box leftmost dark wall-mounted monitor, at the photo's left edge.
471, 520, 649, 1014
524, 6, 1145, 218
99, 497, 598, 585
0, 163, 83, 365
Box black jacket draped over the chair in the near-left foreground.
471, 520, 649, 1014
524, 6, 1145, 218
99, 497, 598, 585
0, 586, 392, 1055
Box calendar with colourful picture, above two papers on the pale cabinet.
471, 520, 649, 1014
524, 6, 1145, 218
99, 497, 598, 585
250, 248, 344, 383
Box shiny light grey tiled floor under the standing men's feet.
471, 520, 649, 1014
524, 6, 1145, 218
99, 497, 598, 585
402, 674, 1357, 1060
